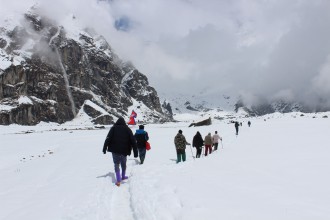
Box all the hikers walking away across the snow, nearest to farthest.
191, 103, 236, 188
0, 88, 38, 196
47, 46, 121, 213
102, 117, 251, 186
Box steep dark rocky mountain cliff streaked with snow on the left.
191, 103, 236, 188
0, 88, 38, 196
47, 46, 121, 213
0, 12, 172, 125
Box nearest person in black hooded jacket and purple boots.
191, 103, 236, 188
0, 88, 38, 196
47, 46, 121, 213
103, 117, 138, 186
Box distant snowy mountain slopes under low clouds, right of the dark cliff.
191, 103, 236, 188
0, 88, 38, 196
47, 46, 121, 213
161, 90, 311, 119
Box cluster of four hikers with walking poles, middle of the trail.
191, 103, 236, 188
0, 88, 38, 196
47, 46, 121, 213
174, 130, 222, 163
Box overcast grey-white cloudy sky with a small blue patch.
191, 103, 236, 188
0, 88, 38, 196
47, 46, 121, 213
0, 0, 330, 107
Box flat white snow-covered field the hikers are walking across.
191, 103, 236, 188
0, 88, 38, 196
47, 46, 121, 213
0, 113, 330, 220
